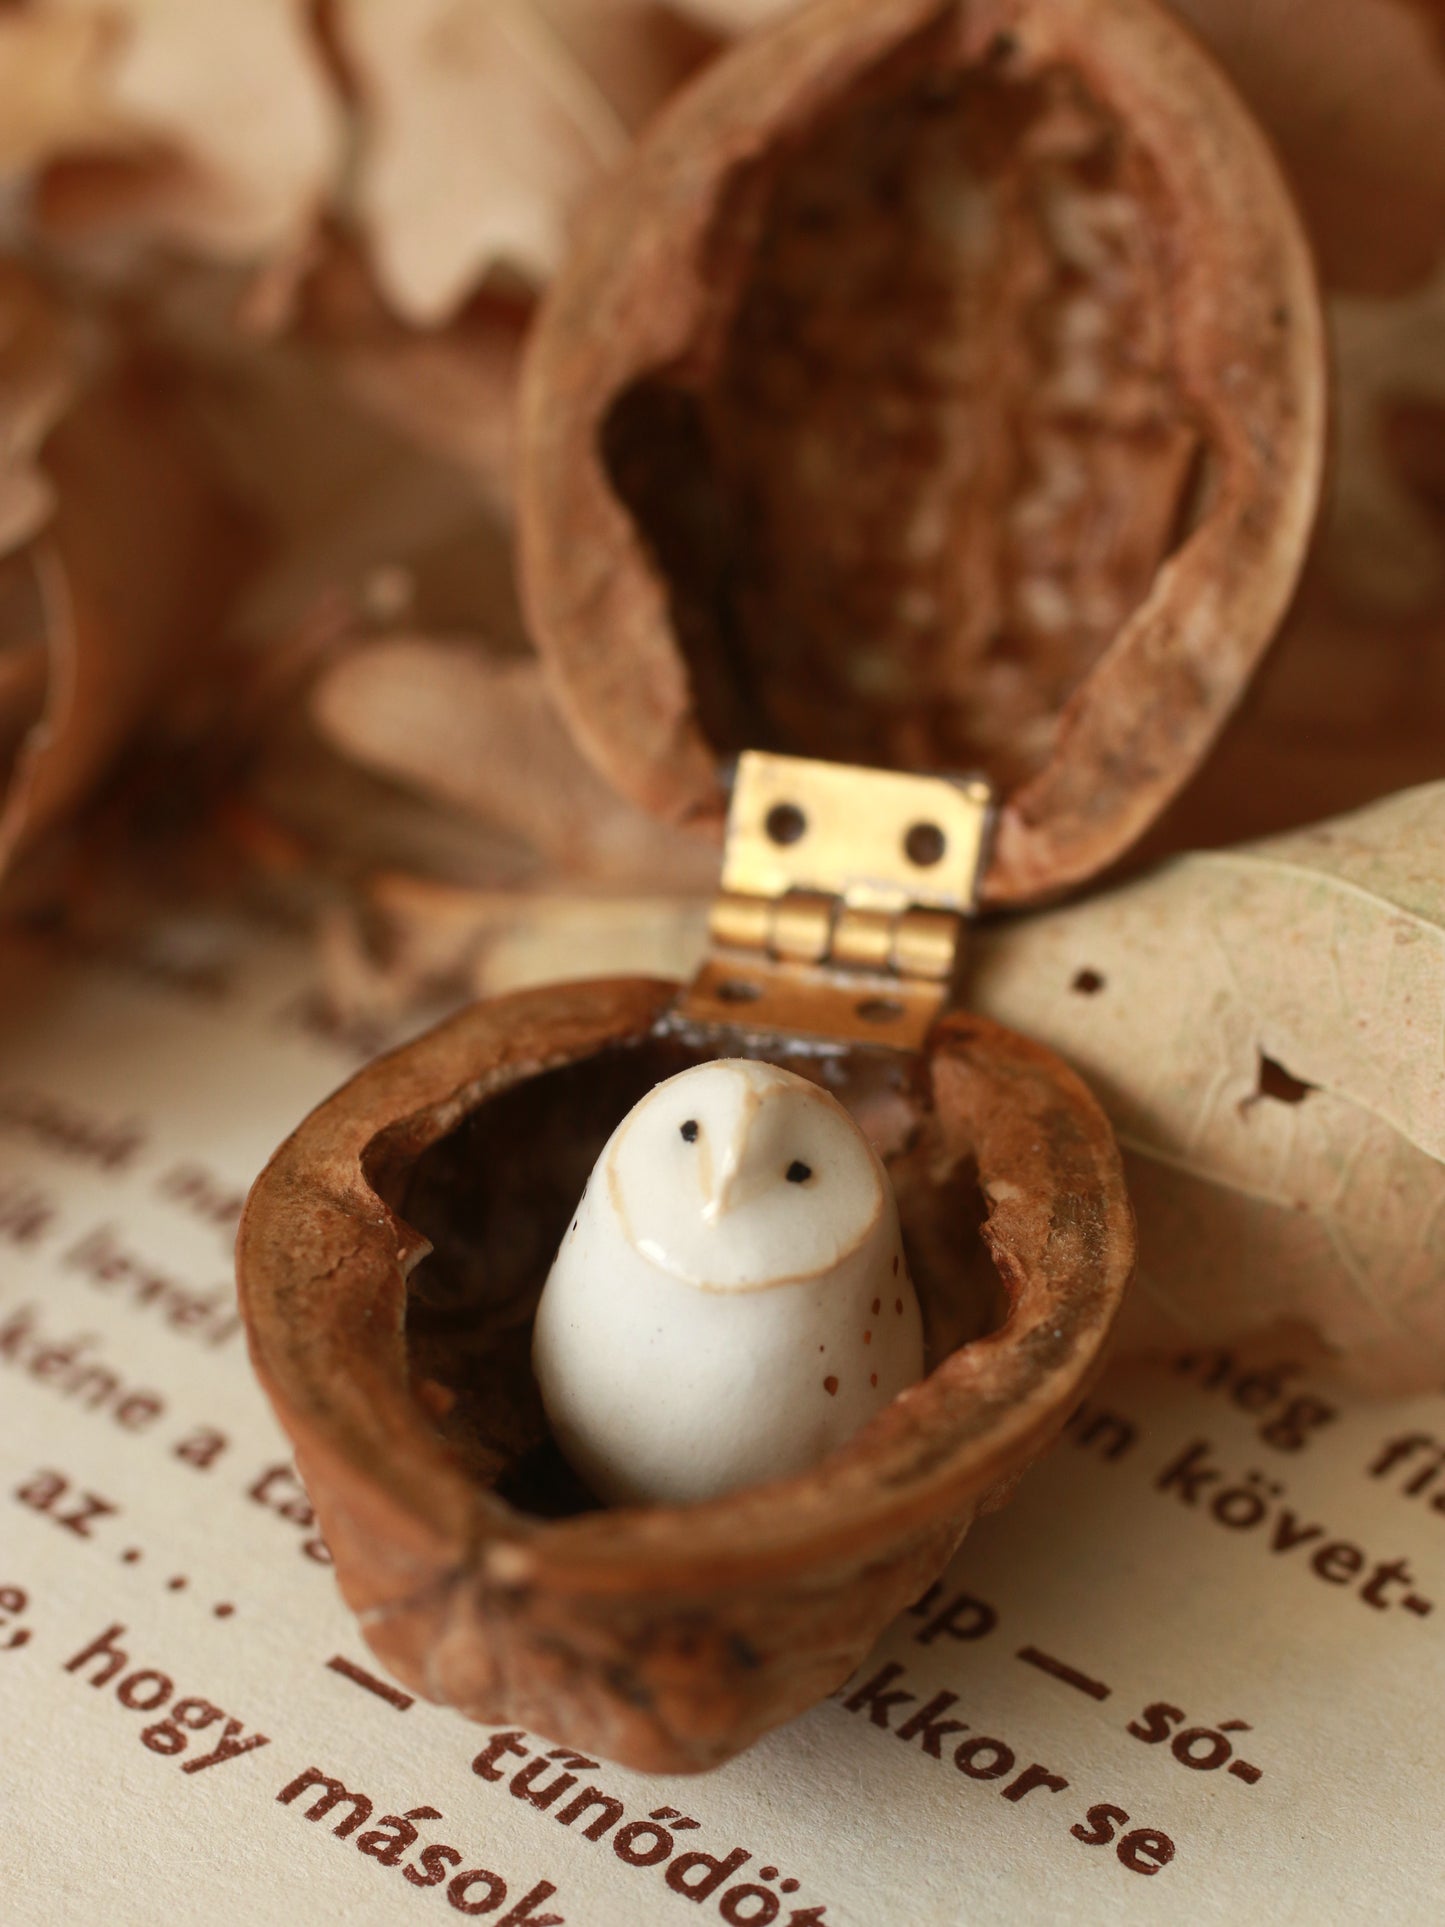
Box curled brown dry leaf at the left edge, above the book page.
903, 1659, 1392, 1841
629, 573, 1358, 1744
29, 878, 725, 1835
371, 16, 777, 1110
0, 264, 250, 869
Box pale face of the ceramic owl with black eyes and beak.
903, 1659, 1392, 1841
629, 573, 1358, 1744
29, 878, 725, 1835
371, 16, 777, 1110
607, 1058, 884, 1291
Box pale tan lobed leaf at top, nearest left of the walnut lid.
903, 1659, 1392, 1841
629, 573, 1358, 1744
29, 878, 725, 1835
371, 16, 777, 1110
335, 0, 724, 328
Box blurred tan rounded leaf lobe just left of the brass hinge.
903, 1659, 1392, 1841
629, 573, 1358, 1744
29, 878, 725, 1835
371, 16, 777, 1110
312, 636, 717, 892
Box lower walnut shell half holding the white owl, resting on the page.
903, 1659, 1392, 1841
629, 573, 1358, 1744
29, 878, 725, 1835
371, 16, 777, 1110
239, 979, 1133, 1773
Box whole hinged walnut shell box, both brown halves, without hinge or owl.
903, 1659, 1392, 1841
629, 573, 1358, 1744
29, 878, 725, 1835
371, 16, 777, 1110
239, 0, 1324, 1771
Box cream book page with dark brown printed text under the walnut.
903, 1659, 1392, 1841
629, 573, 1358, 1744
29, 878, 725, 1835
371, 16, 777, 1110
0, 923, 1445, 1927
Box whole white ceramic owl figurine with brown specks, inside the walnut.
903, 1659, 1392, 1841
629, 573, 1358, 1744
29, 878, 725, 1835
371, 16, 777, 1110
532, 1058, 923, 1503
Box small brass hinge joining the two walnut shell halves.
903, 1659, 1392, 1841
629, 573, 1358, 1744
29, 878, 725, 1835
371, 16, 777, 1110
680, 752, 992, 1050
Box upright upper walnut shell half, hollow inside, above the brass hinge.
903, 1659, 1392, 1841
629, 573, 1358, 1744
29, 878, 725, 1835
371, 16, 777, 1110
520, 0, 1324, 904
